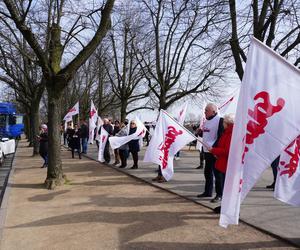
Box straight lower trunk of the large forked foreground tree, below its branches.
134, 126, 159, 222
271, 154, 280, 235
45, 86, 64, 189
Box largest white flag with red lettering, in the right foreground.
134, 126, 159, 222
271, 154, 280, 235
220, 39, 300, 227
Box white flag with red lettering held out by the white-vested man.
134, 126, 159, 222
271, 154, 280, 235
144, 111, 195, 181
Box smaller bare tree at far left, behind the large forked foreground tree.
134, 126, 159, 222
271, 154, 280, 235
0, 38, 45, 155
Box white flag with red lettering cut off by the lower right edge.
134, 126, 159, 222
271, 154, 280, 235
274, 136, 300, 206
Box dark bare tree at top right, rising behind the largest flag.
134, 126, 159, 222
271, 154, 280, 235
229, 0, 300, 80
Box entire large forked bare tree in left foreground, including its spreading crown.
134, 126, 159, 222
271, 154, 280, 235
0, 0, 114, 189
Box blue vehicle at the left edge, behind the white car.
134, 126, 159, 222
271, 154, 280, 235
0, 102, 24, 139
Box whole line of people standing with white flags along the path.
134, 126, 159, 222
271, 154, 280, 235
38, 103, 279, 212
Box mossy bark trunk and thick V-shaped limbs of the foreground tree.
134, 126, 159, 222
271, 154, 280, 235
3, 0, 115, 189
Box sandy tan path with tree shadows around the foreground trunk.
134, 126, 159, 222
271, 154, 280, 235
0, 142, 295, 250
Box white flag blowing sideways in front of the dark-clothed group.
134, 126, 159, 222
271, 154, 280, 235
109, 118, 147, 149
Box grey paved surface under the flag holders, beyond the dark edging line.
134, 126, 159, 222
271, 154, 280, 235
82, 142, 300, 247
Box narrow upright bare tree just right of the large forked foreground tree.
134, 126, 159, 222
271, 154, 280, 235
104, 3, 153, 121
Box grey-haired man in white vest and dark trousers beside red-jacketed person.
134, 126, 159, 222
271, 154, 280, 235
197, 103, 224, 202
